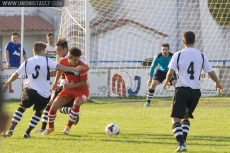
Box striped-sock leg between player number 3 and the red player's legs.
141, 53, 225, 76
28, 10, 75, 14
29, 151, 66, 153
35, 86, 63, 133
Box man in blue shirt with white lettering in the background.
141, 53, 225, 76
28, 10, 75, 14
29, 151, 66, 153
5, 32, 28, 68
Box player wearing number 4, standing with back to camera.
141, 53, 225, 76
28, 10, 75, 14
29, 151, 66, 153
163, 31, 223, 152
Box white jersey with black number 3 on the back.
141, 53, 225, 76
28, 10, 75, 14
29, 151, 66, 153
16, 55, 58, 98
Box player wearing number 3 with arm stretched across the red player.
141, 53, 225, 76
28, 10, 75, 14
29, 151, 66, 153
2, 42, 85, 138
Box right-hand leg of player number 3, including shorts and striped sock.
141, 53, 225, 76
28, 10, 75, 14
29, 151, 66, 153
23, 94, 50, 138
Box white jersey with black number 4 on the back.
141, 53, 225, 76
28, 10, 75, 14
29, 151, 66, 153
168, 47, 213, 89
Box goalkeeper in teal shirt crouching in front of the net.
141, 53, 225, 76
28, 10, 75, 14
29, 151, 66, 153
144, 43, 177, 107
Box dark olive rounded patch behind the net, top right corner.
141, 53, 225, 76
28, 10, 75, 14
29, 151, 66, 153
208, 0, 230, 27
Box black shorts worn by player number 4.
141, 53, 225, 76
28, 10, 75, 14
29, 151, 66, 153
171, 87, 201, 119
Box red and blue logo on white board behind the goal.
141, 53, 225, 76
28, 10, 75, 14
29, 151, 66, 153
112, 72, 141, 97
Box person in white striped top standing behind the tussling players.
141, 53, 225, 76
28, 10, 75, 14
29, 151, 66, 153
45, 33, 56, 61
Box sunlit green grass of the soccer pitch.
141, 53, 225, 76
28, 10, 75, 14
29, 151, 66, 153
0, 97, 230, 153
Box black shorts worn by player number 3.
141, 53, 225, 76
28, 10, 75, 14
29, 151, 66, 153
20, 88, 50, 111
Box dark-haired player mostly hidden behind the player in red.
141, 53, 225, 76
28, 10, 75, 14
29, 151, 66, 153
35, 38, 89, 133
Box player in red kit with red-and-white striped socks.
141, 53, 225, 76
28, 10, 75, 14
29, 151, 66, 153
42, 47, 89, 135
